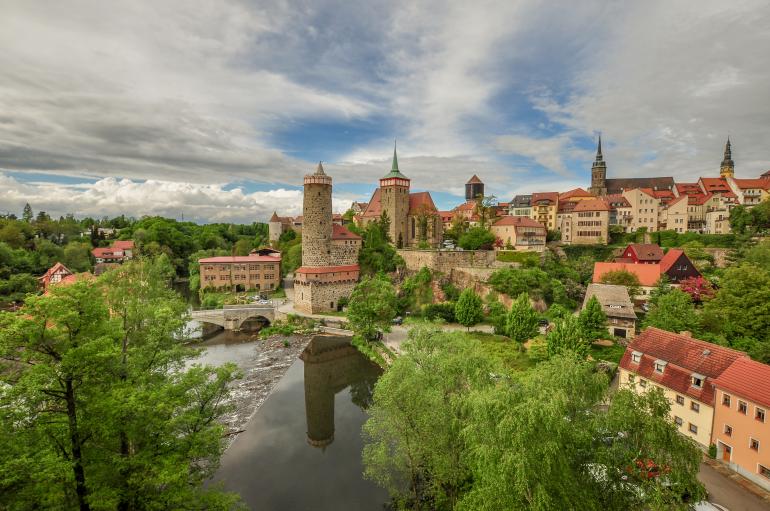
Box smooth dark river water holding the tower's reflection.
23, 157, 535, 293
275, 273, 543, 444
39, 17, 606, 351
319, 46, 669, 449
216, 336, 388, 511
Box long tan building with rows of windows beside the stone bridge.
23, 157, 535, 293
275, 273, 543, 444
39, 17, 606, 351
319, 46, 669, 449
198, 253, 281, 291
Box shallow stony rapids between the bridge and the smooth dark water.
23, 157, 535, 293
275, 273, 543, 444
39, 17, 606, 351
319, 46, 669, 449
192, 332, 312, 446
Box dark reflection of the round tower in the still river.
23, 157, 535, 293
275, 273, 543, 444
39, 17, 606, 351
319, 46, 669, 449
300, 335, 382, 449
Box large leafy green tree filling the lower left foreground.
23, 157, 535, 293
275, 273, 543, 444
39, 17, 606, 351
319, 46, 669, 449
0, 261, 240, 510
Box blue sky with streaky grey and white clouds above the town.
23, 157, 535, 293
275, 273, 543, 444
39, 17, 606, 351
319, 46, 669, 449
0, 0, 770, 223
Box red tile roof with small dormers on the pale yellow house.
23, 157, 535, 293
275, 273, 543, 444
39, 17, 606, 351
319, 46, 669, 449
620, 327, 746, 406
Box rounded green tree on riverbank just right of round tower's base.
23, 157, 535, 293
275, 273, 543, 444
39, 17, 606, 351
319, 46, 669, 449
347, 276, 396, 341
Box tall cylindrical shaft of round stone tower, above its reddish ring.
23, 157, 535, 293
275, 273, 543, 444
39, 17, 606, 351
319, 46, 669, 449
302, 161, 332, 266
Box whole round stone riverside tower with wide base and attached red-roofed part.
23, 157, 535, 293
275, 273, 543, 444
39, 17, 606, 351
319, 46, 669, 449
294, 162, 361, 314
